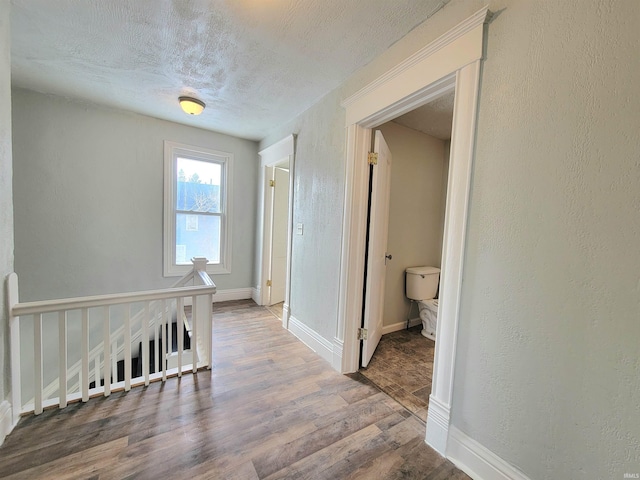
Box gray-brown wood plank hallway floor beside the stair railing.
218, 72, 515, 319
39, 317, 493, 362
0, 301, 469, 480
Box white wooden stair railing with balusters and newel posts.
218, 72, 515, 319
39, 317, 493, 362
8, 259, 216, 422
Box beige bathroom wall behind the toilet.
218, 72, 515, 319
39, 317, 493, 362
380, 122, 444, 325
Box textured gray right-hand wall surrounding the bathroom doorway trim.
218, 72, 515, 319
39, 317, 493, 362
261, 0, 640, 479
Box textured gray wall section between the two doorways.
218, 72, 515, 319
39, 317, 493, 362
260, 92, 344, 341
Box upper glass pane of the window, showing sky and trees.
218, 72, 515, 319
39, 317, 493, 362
176, 157, 222, 213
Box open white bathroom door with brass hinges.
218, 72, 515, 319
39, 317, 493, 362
362, 130, 391, 367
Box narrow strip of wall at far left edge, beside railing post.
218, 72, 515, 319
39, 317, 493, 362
0, 0, 13, 403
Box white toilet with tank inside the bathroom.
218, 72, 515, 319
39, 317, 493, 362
406, 267, 440, 340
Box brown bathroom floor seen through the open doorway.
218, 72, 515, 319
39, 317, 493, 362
360, 325, 436, 422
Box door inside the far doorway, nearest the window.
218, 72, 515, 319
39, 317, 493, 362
269, 167, 289, 305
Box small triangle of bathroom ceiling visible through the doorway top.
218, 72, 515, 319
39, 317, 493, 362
393, 92, 454, 140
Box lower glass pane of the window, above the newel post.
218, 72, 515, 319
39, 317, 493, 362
176, 213, 220, 265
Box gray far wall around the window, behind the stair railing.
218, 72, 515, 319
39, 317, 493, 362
13, 89, 258, 301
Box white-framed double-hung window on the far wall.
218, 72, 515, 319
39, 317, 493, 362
164, 142, 233, 276
